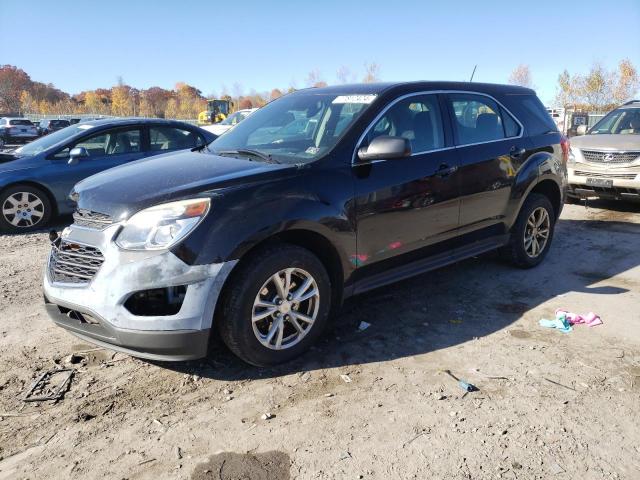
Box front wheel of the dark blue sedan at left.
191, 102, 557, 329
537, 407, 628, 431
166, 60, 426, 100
0, 185, 53, 233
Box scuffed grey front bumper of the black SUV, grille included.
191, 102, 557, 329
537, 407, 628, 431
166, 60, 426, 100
44, 225, 236, 361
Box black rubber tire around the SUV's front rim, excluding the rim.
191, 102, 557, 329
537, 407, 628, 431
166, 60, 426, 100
219, 245, 331, 366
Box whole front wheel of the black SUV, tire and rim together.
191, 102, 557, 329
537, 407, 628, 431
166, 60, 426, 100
219, 244, 331, 367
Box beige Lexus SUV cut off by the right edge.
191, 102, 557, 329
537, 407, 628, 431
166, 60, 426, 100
568, 100, 640, 201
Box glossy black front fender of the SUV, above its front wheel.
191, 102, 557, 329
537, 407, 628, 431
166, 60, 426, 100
174, 170, 356, 284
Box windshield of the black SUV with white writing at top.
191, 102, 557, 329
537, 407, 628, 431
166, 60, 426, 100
209, 93, 375, 163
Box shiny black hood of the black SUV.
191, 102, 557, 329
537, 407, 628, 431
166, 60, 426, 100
72, 150, 293, 219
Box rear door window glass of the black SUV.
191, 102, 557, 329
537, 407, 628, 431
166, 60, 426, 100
449, 94, 505, 145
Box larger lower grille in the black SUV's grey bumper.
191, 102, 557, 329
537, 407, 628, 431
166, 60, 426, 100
49, 240, 104, 283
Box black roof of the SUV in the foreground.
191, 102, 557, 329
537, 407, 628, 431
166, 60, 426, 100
293, 80, 535, 95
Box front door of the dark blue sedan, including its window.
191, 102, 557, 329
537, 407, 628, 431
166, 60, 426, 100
47, 126, 145, 208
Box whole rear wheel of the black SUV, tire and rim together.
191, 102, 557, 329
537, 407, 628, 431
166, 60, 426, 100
503, 193, 556, 268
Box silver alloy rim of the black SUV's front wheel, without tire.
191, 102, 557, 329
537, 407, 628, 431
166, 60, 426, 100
251, 268, 320, 350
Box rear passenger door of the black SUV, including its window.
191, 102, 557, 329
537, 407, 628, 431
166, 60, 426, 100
447, 93, 528, 237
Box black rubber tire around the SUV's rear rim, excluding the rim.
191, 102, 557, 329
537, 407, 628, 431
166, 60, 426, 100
510, 193, 556, 268
